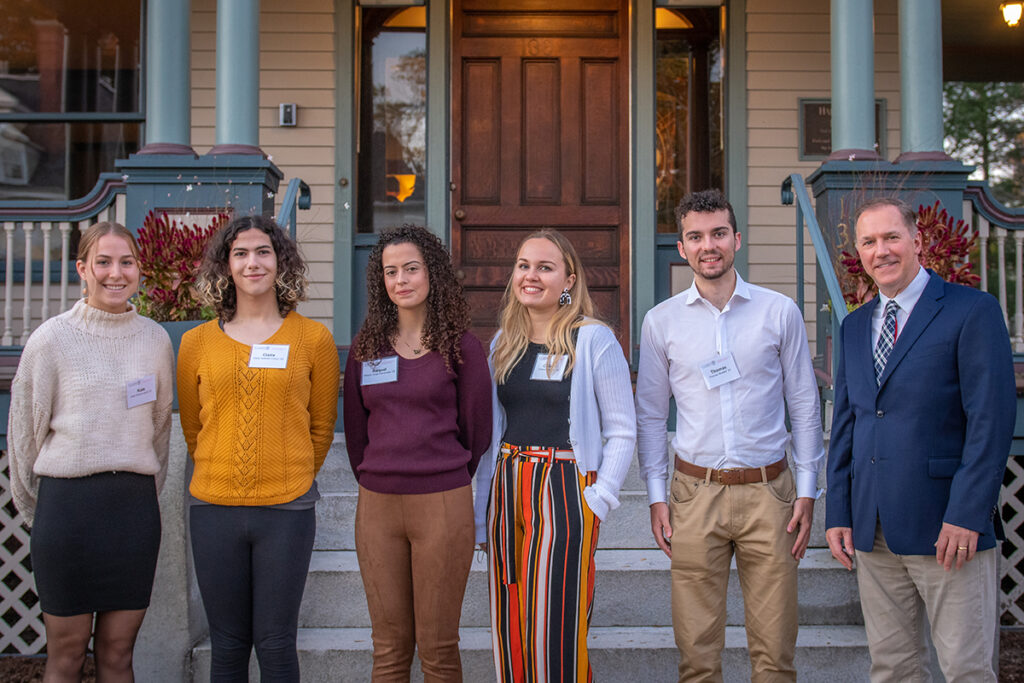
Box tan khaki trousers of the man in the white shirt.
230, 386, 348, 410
669, 470, 797, 683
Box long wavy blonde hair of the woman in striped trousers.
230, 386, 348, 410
494, 227, 599, 384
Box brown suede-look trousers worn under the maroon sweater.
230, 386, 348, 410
355, 486, 474, 683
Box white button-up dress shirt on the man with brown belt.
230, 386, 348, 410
637, 273, 824, 504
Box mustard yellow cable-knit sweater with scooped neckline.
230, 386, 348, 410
178, 312, 339, 505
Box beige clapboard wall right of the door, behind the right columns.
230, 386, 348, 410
744, 0, 900, 335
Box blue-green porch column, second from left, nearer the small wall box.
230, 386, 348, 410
210, 0, 263, 155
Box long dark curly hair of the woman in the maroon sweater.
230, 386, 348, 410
351, 224, 469, 371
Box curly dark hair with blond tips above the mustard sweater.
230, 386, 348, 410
196, 214, 309, 323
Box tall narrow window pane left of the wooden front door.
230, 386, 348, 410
356, 7, 427, 232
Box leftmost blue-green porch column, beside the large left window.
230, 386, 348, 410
139, 0, 196, 157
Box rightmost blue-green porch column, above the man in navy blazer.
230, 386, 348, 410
897, 0, 949, 161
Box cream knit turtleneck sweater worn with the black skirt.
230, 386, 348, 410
7, 299, 174, 526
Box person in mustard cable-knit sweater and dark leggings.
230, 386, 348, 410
178, 216, 339, 681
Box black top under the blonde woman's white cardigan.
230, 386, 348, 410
498, 343, 572, 449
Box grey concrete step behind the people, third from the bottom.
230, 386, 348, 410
314, 490, 827, 550
